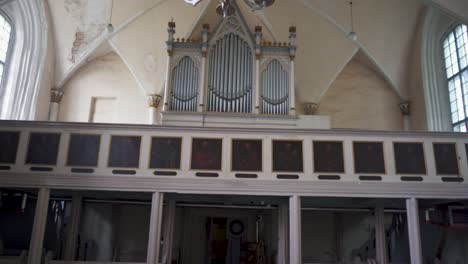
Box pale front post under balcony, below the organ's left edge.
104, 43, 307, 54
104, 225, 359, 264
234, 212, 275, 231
146, 192, 164, 264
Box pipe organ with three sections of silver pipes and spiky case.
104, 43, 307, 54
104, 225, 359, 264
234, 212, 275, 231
163, 4, 296, 115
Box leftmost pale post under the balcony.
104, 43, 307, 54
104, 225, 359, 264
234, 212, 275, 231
28, 188, 50, 264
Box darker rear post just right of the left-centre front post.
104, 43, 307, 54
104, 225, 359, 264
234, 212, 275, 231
162, 200, 176, 264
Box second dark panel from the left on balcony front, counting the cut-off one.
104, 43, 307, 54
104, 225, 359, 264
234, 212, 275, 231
26, 133, 60, 166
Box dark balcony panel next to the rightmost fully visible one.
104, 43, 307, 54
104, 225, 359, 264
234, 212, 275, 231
393, 143, 426, 174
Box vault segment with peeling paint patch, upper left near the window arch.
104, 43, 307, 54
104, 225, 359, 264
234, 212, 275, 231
64, 0, 112, 63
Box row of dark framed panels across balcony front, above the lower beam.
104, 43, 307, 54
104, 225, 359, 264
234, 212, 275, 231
0, 122, 468, 186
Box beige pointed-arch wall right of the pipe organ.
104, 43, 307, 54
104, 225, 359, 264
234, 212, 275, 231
318, 53, 403, 130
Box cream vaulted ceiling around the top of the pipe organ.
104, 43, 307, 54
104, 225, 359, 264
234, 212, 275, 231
47, 0, 468, 105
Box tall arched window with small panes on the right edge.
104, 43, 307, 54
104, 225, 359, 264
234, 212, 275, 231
443, 25, 468, 132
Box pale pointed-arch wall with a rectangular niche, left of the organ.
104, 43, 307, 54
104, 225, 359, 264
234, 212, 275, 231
59, 53, 148, 124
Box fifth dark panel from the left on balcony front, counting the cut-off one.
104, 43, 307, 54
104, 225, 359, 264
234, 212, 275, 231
150, 137, 182, 170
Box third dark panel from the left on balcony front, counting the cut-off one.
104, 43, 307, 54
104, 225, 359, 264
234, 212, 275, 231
67, 134, 101, 167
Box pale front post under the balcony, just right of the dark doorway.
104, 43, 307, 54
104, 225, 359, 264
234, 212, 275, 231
289, 195, 302, 264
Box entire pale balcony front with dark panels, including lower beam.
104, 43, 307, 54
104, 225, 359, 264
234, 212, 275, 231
0, 121, 468, 197
